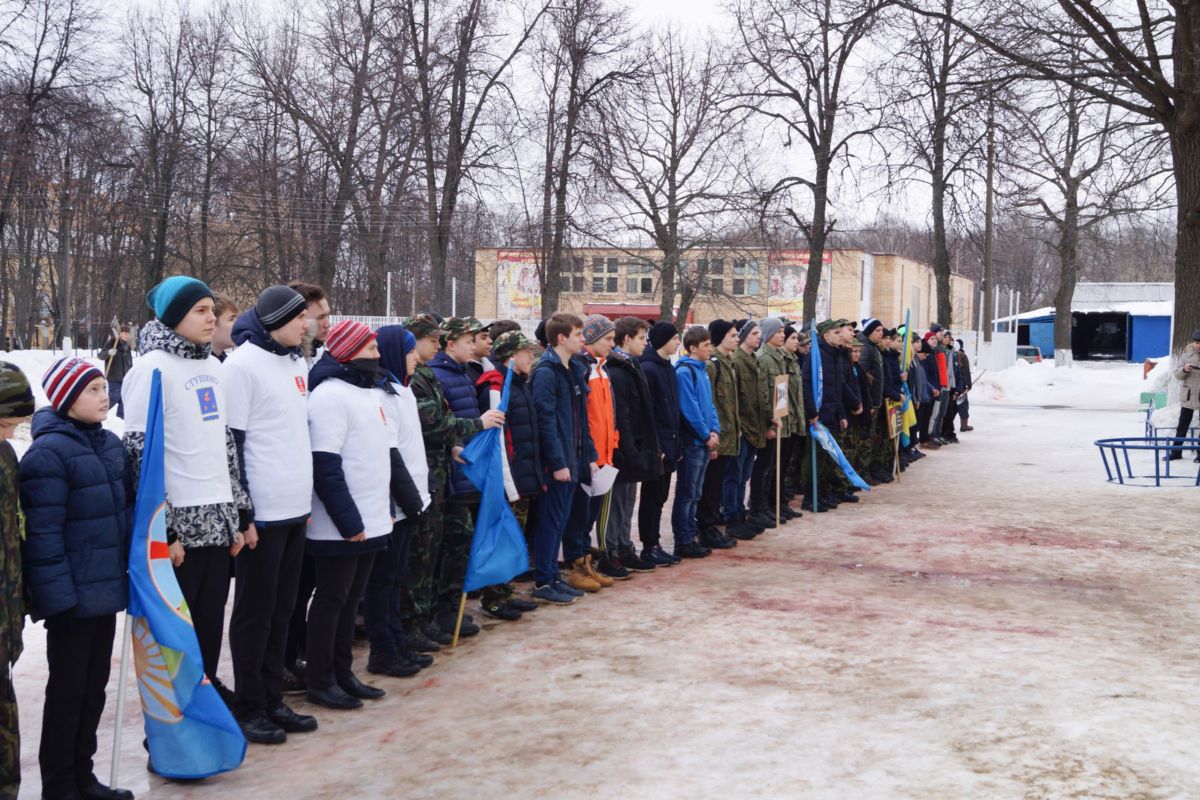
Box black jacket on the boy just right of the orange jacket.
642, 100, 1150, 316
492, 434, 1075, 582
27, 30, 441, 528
605, 350, 662, 483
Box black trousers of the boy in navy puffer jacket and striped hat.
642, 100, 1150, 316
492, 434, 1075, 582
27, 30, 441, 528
37, 614, 115, 798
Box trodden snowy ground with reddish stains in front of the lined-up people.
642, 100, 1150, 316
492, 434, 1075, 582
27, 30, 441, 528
4, 363, 1200, 800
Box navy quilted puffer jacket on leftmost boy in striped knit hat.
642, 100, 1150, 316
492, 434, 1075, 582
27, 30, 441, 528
20, 408, 133, 620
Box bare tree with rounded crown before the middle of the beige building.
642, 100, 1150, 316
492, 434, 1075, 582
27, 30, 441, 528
589, 29, 745, 324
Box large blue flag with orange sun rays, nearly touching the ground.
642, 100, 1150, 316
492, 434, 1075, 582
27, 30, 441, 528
128, 369, 246, 778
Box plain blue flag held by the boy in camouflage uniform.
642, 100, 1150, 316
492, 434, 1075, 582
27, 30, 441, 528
462, 368, 529, 591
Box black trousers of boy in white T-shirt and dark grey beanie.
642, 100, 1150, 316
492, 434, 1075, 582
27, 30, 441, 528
229, 521, 307, 720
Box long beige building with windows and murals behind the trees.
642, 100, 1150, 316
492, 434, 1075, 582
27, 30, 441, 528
475, 247, 977, 330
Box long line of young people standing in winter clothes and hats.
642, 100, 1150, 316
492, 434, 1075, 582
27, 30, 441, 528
0, 276, 971, 799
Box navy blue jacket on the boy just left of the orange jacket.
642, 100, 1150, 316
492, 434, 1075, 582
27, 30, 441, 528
530, 349, 596, 483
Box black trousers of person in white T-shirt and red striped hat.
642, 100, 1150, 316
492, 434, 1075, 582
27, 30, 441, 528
305, 553, 376, 691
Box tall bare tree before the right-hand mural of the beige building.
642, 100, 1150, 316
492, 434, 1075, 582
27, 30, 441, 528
734, 0, 892, 324
